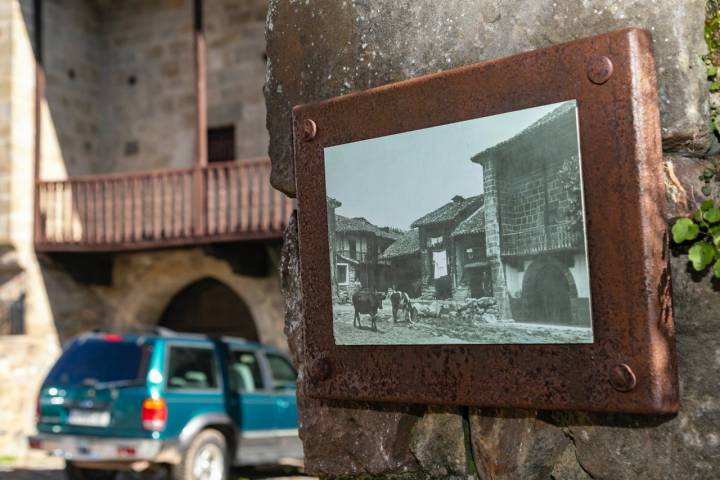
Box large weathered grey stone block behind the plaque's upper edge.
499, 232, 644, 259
265, 0, 708, 194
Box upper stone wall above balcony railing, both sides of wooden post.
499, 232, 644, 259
36, 0, 268, 178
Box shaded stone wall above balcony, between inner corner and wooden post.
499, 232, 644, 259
94, 0, 196, 172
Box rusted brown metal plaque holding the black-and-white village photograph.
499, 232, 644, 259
294, 29, 678, 413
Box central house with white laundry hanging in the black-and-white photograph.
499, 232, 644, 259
411, 195, 483, 299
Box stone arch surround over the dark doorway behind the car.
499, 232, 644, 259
107, 249, 287, 349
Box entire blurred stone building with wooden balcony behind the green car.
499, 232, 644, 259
0, 0, 293, 458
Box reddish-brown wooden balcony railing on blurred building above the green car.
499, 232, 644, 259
35, 159, 294, 251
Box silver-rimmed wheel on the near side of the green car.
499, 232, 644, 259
172, 429, 230, 480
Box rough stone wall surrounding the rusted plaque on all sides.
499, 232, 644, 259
265, 0, 720, 480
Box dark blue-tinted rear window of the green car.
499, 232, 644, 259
45, 338, 152, 386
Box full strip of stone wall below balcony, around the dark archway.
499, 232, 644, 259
42, 247, 287, 350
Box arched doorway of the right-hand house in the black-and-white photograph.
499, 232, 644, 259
522, 258, 577, 325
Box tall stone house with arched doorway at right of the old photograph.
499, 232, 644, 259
472, 102, 590, 326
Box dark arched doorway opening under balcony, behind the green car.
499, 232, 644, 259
158, 277, 259, 341
